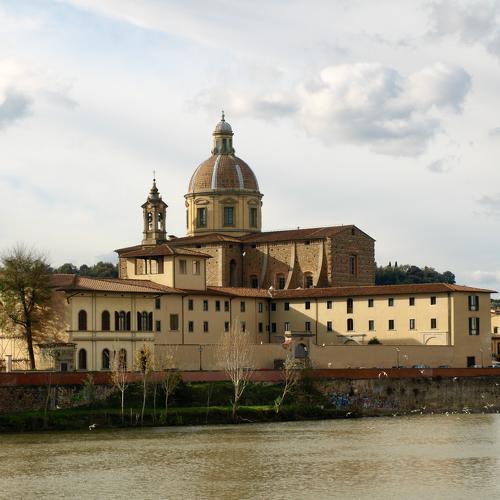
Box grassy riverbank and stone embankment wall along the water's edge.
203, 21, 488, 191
0, 372, 500, 432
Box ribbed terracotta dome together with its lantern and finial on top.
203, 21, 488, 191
188, 112, 259, 194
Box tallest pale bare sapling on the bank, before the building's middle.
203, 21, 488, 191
217, 322, 253, 420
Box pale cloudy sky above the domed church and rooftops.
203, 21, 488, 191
0, 0, 500, 290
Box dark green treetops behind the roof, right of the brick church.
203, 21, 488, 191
375, 262, 455, 285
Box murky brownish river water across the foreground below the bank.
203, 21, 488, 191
0, 414, 500, 500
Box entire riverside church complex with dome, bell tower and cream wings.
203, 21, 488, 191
0, 115, 491, 371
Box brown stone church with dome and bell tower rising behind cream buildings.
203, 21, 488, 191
117, 113, 375, 290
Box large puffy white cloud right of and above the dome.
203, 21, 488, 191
194, 63, 471, 156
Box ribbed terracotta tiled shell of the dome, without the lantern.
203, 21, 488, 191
188, 154, 259, 193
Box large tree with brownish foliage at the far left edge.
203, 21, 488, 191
0, 245, 55, 370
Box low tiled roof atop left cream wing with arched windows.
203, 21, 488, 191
51, 274, 184, 294
